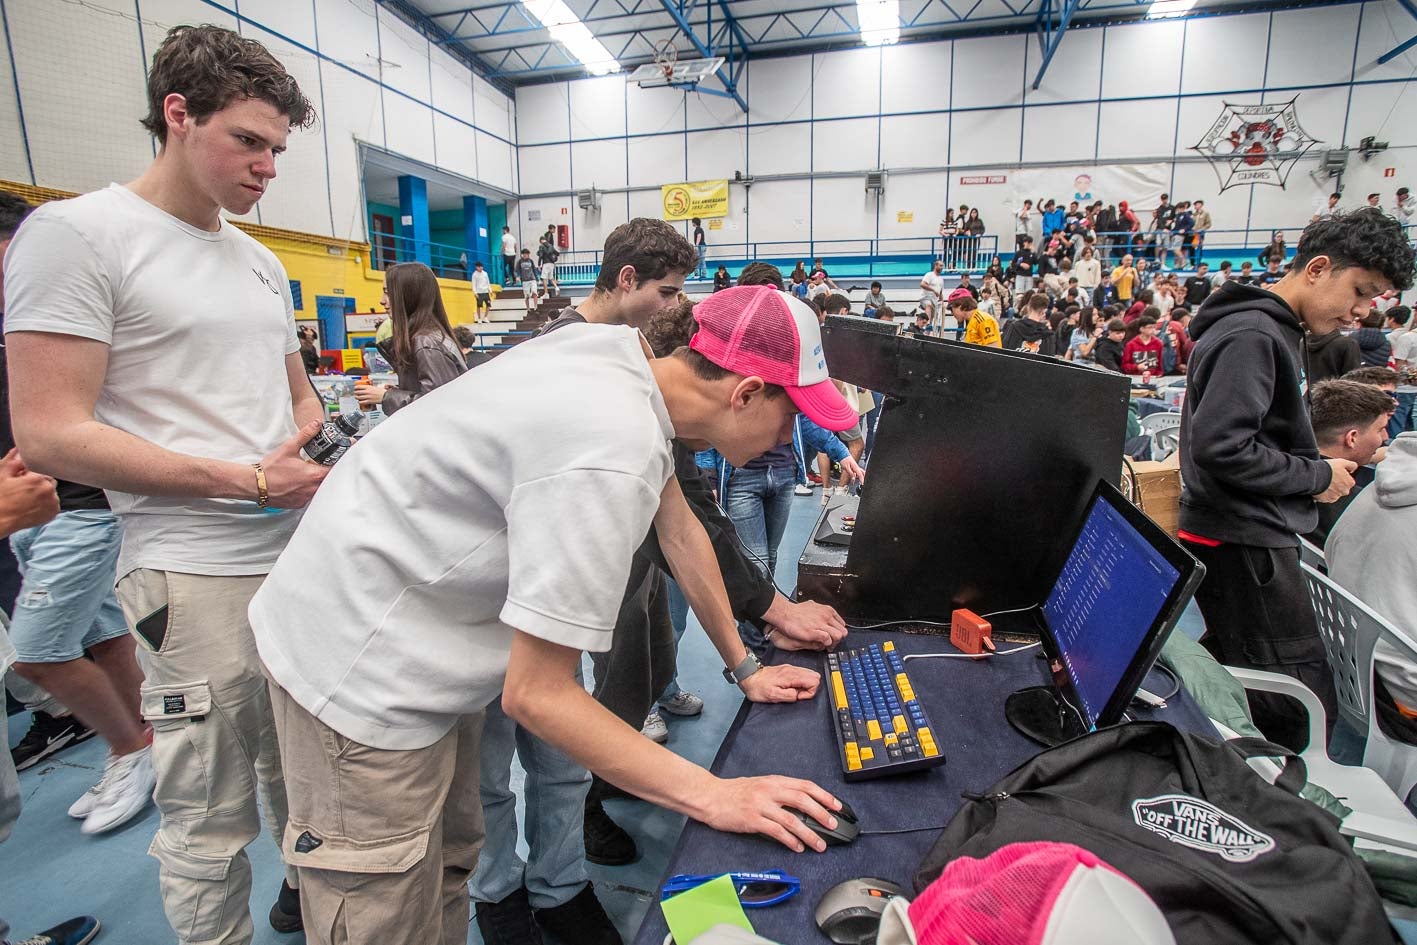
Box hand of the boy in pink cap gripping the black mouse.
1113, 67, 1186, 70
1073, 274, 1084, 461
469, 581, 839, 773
697, 782, 842, 853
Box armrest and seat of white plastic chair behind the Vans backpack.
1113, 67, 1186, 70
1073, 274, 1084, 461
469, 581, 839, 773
1214, 666, 1417, 867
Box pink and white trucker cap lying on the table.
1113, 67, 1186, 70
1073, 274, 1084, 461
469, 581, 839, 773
906, 843, 1176, 945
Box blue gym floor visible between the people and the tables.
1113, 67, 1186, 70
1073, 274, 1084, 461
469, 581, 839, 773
8, 494, 1417, 945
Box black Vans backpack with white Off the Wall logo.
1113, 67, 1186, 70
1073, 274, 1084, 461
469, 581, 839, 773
915, 723, 1396, 945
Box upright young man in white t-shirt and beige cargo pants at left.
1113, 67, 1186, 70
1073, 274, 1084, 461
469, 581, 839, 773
4, 27, 326, 945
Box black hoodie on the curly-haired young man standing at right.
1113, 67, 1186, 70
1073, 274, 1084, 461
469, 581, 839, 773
1180, 282, 1333, 548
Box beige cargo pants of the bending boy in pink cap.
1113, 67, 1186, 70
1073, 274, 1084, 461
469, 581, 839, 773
271, 681, 483, 945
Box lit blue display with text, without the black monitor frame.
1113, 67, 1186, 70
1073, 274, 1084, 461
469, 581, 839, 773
1043, 496, 1180, 728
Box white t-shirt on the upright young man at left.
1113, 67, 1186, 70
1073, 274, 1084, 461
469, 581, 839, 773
4, 184, 300, 577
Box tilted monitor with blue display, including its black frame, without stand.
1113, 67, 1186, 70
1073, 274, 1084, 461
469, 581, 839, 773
1043, 483, 1199, 730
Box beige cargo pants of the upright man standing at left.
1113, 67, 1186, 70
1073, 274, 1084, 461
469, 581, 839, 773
118, 570, 296, 945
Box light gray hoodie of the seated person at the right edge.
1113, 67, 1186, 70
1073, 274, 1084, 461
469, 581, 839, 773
1323, 432, 1417, 708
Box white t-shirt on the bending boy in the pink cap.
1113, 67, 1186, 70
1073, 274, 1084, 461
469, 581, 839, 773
249, 324, 674, 749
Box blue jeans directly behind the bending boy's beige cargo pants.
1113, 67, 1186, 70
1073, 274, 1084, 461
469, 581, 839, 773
472, 670, 591, 910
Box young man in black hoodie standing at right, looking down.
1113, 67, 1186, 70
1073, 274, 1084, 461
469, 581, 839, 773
1179, 210, 1413, 748
